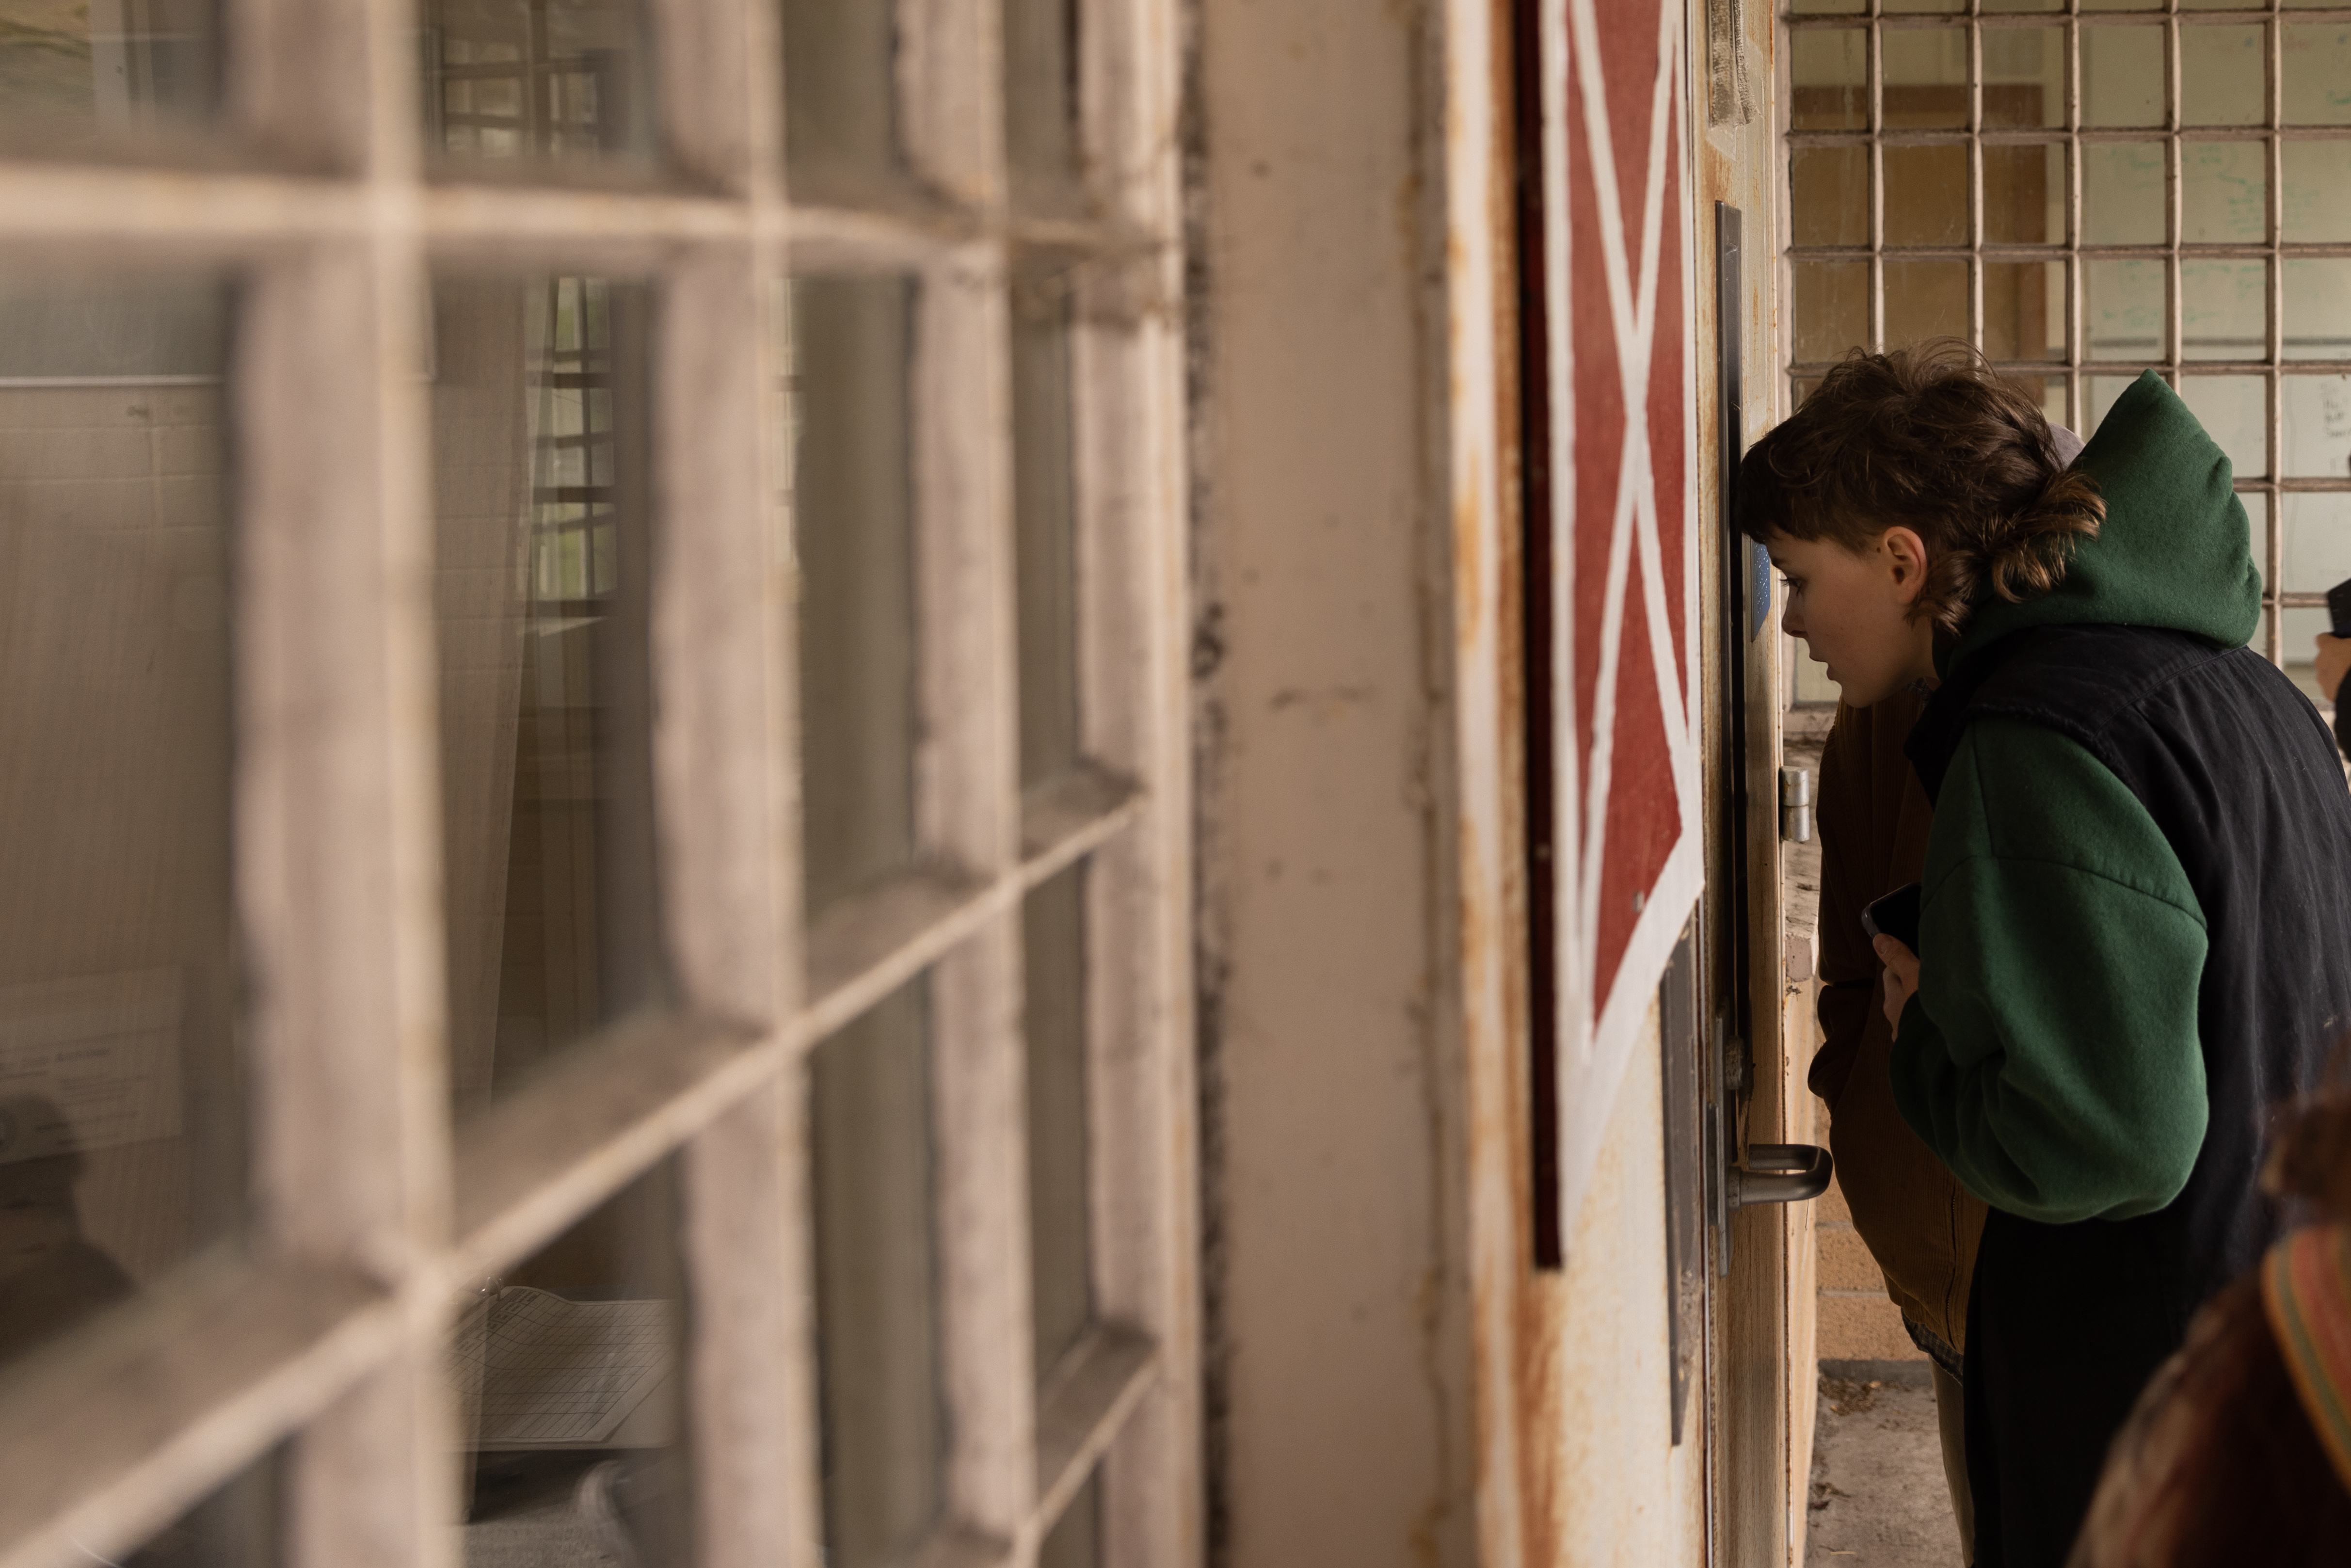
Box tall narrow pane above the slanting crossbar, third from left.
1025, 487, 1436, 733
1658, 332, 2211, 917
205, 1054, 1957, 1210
783, 277, 917, 917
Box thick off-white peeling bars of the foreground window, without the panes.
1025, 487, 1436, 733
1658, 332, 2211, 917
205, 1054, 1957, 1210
0, 0, 1201, 1568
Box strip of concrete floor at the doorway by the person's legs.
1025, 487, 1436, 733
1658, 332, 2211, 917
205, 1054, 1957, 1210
1803, 1361, 1958, 1568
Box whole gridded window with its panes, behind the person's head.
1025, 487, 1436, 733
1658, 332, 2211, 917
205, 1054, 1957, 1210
1780, 0, 2351, 701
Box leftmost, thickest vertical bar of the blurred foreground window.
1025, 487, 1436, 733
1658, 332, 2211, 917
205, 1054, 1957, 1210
235, 61, 456, 1568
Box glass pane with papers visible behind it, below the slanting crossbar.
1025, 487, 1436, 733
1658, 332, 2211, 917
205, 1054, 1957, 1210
449, 1156, 691, 1568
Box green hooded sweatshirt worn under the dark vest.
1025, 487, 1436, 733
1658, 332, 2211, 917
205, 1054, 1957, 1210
1890, 371, 2262, 1225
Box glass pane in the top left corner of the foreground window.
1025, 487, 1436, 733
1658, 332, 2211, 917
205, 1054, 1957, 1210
0, 0, 221, 150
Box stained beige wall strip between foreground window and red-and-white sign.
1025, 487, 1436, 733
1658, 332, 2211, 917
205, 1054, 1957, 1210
1192, 0, 1474, 1568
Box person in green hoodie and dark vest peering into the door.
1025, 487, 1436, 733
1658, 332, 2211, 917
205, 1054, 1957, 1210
1737, 343, 2351, 1568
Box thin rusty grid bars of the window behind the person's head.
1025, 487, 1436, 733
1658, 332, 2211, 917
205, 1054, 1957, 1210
1777, 0, 2351, 665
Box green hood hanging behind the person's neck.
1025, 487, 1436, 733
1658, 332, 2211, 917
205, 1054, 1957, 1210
1937, 371, 2262, 668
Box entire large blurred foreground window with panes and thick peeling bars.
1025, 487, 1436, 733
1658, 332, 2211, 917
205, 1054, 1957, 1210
0, 0, 1199, 1568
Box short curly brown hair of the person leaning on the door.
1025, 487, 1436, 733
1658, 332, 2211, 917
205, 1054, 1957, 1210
1737, 338, 2107, 632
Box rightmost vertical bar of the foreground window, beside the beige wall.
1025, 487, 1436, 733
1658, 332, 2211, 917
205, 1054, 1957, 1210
1076, 0, 1201, 1542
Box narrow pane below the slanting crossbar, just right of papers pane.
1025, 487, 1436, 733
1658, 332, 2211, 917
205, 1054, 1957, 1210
809, 980, 947, 1568
